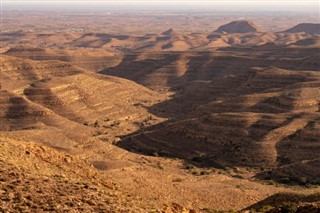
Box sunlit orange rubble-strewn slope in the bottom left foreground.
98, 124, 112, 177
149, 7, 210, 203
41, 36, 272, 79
0, 135, 141, 212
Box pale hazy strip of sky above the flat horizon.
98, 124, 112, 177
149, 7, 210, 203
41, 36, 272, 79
0, 0, 320, 13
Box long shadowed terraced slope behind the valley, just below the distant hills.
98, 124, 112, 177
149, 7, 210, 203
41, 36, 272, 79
101, 48, 319, 93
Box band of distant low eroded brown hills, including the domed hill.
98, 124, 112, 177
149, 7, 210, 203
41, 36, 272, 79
1, 21, 319, 52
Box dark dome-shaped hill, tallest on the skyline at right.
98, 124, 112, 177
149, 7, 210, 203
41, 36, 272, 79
216, 20, 260, 33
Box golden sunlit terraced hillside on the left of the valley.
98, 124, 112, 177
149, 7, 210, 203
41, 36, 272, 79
1, 56, 166, 141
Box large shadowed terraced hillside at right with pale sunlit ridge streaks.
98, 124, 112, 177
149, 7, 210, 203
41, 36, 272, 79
119, 65, 320, 179
